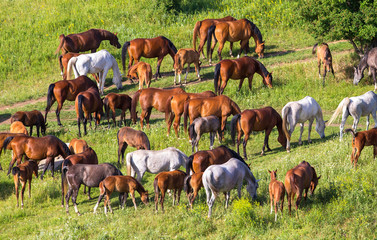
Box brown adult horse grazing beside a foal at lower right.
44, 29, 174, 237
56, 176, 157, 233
284, 161, 321, 217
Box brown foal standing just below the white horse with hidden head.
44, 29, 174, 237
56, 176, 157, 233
153, 170, 186, 212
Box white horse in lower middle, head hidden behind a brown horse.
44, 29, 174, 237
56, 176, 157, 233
126, 147, 188, 182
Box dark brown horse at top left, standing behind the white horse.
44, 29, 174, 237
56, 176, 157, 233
55, 29, 121, 54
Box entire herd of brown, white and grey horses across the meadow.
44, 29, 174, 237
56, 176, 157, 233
0, 16, 377, 221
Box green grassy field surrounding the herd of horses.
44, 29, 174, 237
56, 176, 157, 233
0, 0, 377, 239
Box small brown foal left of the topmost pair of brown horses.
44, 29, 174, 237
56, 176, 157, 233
174, 48, 202, 85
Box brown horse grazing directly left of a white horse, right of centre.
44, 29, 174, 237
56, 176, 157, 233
230, 107, 287, 159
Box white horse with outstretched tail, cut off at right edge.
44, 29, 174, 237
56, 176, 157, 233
328, 91, 377, 140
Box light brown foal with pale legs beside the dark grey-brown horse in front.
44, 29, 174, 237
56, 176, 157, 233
94, 176, 149, 215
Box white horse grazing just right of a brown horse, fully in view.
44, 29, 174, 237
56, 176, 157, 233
281, 96, 326, 152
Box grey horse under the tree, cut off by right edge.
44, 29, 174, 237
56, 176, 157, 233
353, 48, 377, 91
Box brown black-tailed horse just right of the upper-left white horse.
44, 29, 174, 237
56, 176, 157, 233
122, 36, 177, 79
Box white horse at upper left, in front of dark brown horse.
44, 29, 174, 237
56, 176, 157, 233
67, 49, 122, 95
